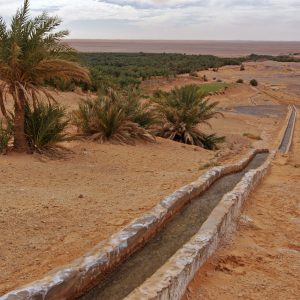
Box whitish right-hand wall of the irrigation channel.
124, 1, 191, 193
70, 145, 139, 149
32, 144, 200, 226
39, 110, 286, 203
124, 106, 297, 300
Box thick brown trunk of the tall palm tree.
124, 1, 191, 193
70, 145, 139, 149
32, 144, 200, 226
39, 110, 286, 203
14, 90, 29, 153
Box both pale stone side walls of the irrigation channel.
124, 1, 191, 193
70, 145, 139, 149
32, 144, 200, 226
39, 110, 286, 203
0, 109, 292, 300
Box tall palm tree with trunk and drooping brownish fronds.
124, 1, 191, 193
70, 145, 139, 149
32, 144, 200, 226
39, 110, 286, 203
0, 0, 89, 152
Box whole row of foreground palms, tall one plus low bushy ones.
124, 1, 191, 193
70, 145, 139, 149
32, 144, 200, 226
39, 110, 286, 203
0, 0, 223, 152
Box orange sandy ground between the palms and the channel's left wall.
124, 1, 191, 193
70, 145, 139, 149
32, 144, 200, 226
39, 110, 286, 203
0, 59, 293, 295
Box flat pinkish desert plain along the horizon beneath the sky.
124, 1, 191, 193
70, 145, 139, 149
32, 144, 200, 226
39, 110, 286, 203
66, 39, 300, 57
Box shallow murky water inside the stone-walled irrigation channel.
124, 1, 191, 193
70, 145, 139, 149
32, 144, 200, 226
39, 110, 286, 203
78, 108, 296, 300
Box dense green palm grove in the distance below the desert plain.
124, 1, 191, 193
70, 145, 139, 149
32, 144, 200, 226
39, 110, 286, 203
79, 53, 243, 91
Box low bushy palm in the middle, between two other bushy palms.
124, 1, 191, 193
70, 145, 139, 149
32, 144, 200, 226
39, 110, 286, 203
73, 90, 154, 145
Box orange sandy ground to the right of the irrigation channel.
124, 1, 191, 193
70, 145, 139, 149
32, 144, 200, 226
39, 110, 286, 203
183, 113, 300, 300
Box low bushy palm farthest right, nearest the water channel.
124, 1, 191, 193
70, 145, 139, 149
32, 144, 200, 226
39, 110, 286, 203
153, 85, 224, 149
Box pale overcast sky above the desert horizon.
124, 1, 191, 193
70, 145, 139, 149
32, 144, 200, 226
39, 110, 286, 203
0, 0, 300, 41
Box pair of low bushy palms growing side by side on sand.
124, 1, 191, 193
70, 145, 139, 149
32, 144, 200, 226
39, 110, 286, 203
72, 84, 224, 149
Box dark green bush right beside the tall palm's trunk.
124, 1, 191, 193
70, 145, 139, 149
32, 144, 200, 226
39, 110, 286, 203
25, 103, 69, 152
